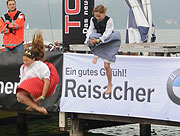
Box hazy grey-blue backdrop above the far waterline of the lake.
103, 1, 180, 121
0, 0, 180, 29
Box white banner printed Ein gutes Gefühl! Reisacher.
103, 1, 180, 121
60, 53, 180, 122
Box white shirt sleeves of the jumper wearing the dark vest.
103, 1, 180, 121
84, 17, 114, 44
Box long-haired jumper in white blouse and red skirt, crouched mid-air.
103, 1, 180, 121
16, 31, 59, 114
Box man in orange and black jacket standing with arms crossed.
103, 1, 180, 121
0, 0, 25, 52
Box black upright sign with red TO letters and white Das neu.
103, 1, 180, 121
62, 0, 94, 49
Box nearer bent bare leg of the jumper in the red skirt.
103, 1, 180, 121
17, 90, 48, 115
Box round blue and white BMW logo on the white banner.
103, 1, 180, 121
167, 69, 180, 105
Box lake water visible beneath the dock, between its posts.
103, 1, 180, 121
0, 116, 180, 136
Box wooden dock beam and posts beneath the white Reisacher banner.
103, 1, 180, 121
59, 113, 180, 136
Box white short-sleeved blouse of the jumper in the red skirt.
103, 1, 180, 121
19, 61, 50, 84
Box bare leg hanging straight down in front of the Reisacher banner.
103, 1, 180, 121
104, 62, 112, 94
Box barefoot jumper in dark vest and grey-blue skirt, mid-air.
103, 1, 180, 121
85, 5, 121, 94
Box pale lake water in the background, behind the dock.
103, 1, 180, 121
0, 29, 180, 45
